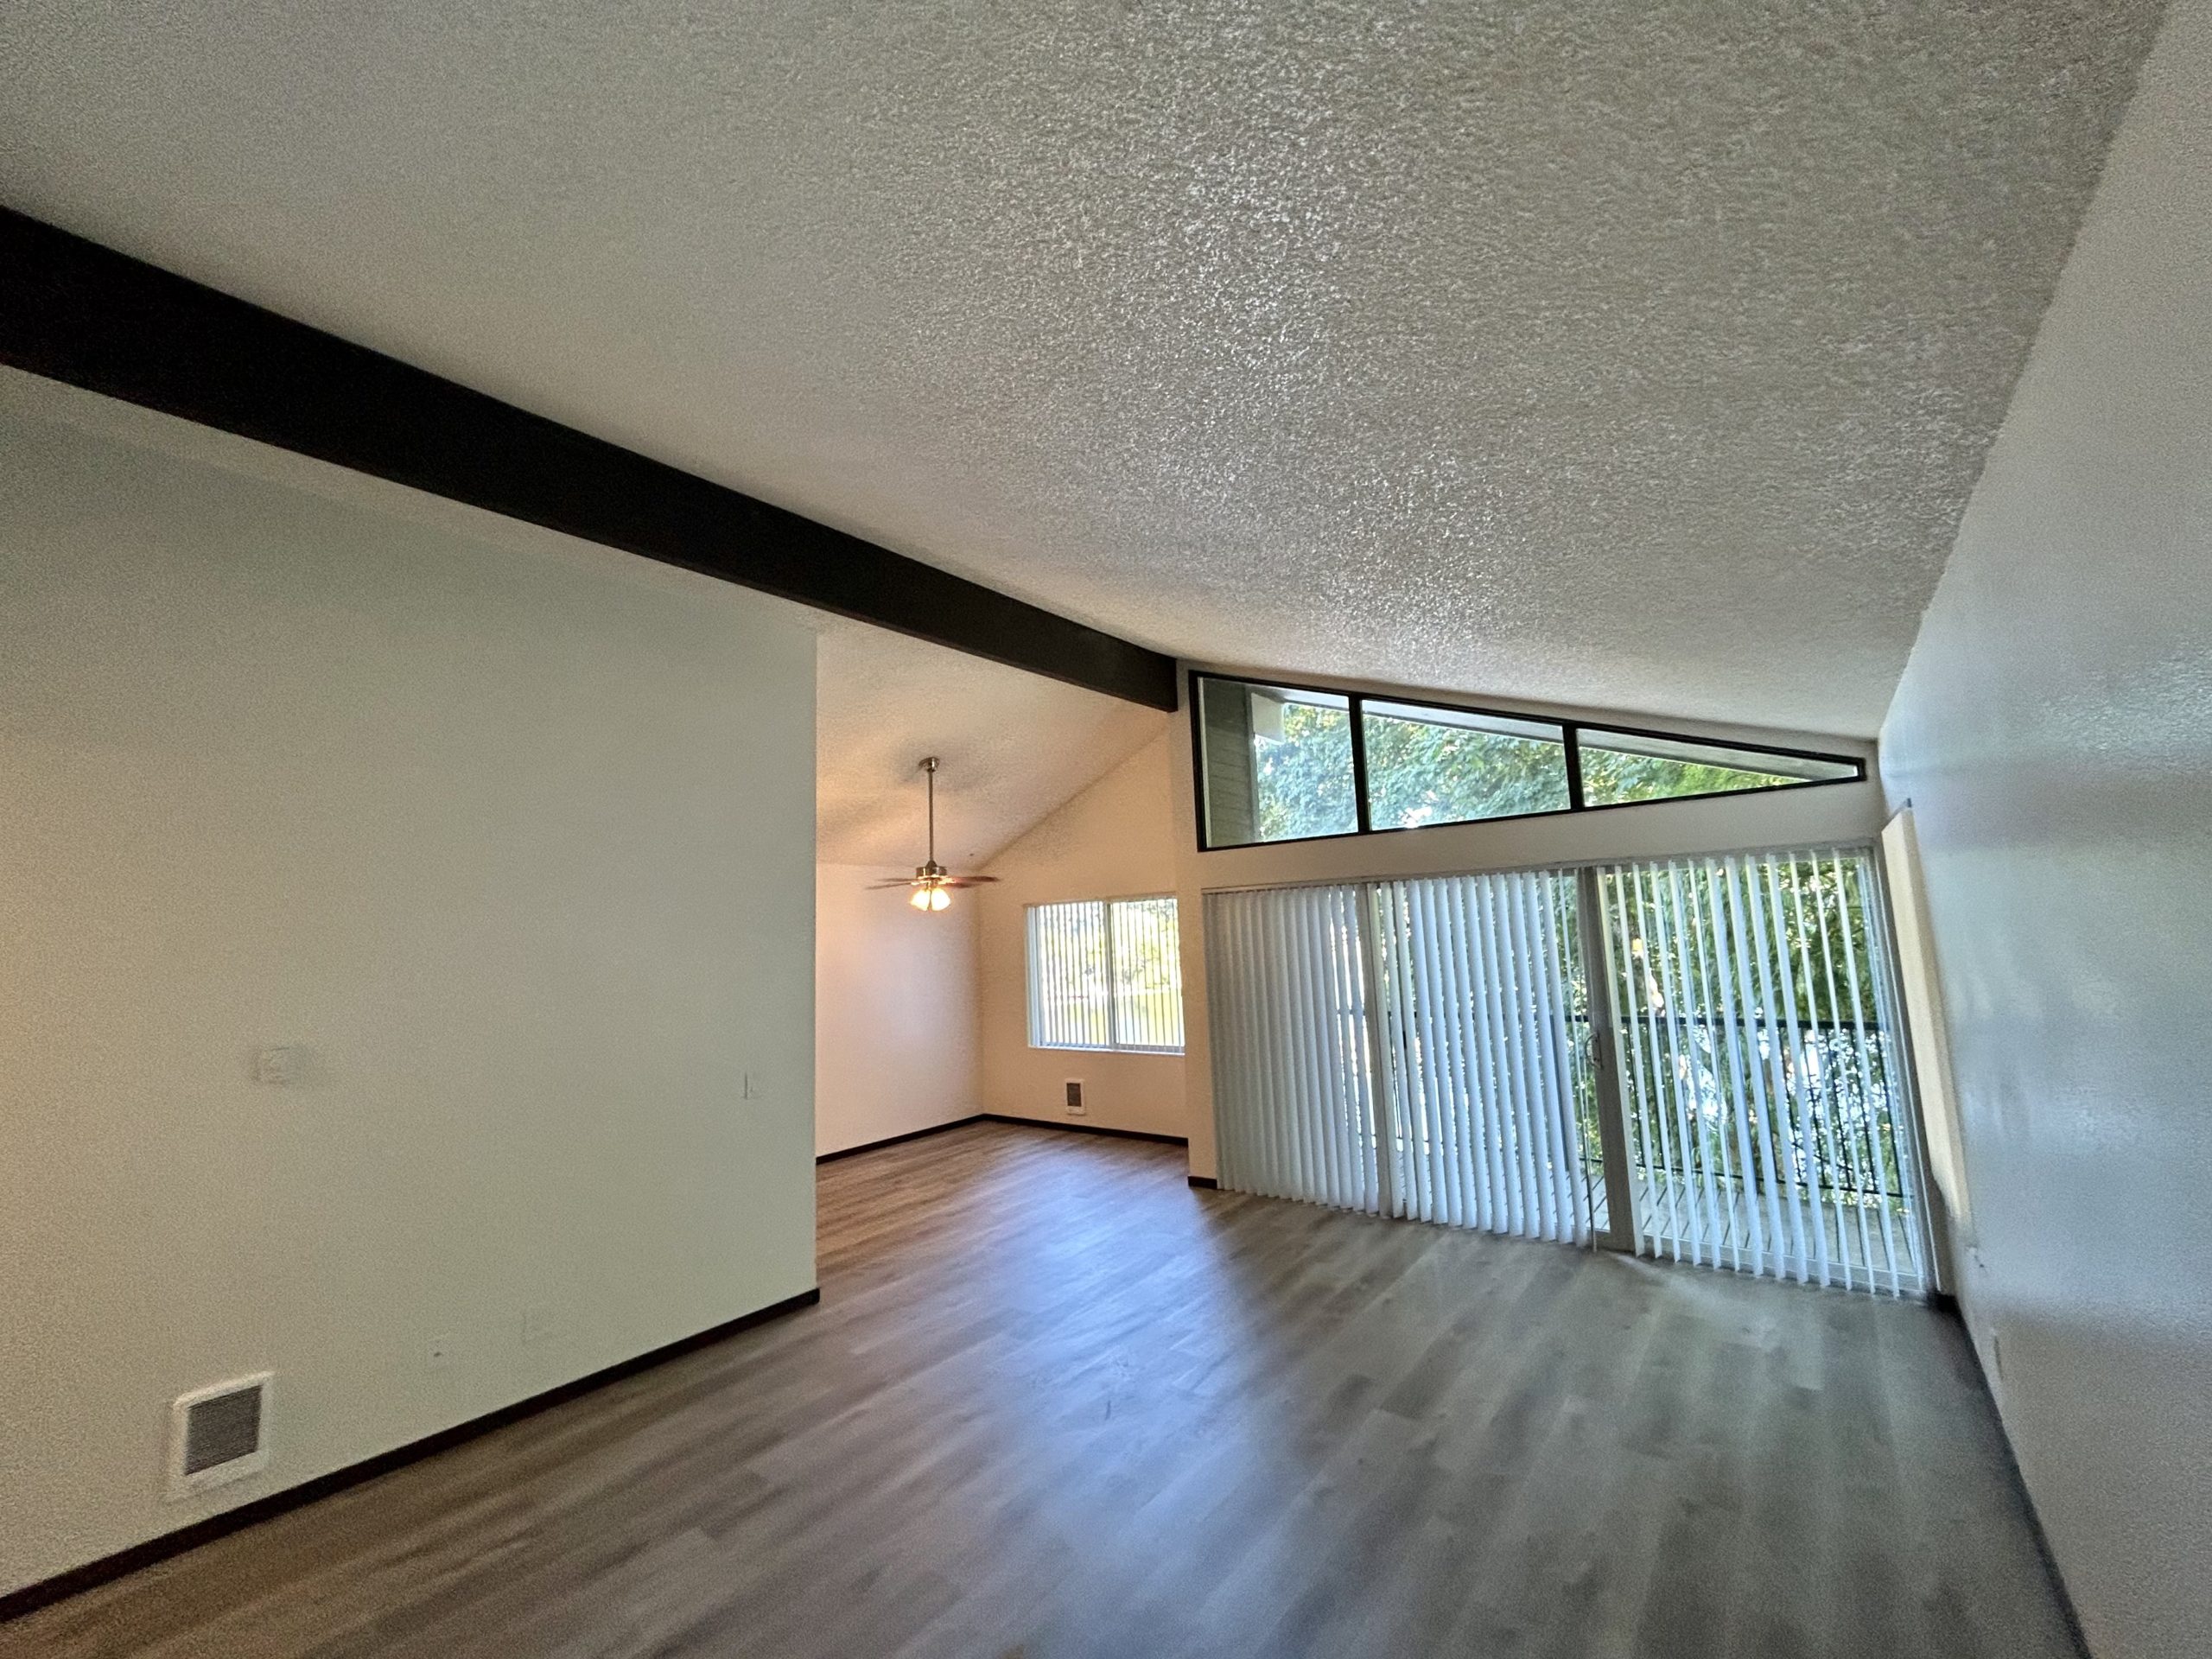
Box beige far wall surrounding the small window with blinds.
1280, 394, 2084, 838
976, 739, 1185, 1135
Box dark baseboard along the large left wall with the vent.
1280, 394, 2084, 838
0, 1287, 823, 1624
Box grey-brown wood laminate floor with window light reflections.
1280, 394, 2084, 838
0, 1123, 2075, 1659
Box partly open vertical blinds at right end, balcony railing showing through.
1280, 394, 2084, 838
1599, 852, 1927, 1294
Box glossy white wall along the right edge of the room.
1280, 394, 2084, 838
1883, 13, 2212, 1659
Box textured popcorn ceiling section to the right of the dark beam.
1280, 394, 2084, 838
0, 0, 2159, 734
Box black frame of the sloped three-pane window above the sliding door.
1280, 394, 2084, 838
1184, 668, 1867, 852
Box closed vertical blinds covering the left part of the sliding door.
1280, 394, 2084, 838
1205, 874, 1592, 1241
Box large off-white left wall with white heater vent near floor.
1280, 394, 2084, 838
0, 378, 814, 1591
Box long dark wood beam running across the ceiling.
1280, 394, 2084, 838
0, 208, 1177, 708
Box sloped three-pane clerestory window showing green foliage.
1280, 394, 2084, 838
1192, 675, 1867, 847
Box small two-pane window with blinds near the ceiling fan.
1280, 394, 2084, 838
1028, 898, 1184, 1053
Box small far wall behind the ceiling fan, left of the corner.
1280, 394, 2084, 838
814, 865, 982, 1153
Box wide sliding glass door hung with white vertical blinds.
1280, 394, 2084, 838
1205, 852, 1927, 1294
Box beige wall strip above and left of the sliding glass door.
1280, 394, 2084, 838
1166, 675, 1885, 1177
